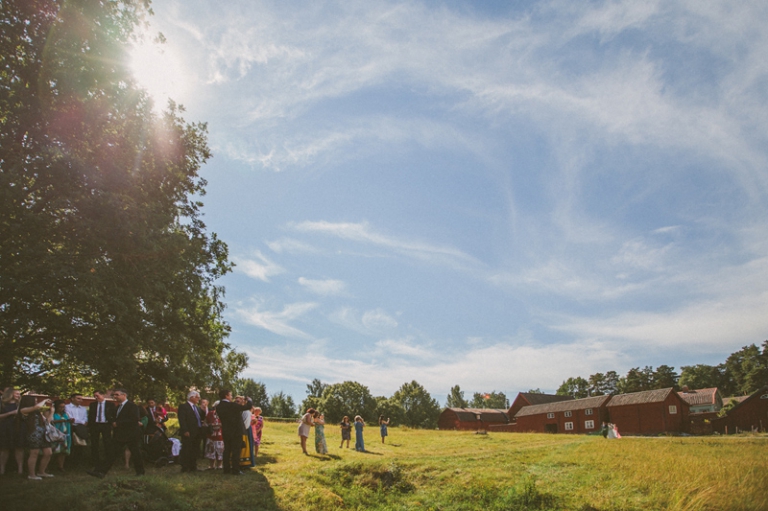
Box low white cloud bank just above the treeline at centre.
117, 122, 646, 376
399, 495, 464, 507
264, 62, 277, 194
238, 339, 628, 398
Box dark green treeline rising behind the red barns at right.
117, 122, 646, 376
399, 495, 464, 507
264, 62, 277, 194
557, 341, 768, 398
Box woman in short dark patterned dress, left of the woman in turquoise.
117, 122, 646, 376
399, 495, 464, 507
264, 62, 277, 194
16, 396, 53, 481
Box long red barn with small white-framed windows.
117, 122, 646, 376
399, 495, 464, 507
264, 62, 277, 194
515, 396, 611, 434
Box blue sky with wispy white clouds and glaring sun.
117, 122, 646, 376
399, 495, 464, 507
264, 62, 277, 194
132, 0, 768, 405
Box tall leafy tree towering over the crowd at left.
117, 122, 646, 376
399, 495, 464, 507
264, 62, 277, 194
0, 0, 240, 400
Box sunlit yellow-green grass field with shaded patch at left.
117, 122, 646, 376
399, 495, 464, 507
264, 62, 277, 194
6, 422, 768, 511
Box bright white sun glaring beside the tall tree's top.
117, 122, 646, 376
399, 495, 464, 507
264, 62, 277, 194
129, 30, 191, 110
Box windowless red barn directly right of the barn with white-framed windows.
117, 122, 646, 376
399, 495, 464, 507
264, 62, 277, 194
607, 387, 689, 435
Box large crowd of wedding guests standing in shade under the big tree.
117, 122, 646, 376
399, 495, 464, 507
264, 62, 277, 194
0, 387, 264, 481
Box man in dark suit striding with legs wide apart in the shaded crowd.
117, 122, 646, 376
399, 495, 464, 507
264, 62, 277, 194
88, 389, 144, 477
